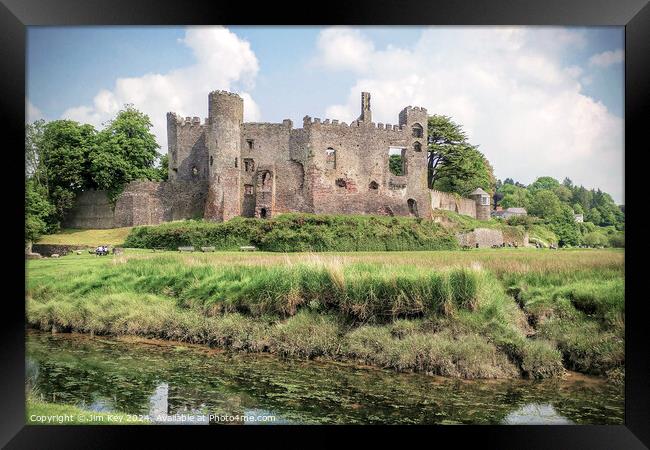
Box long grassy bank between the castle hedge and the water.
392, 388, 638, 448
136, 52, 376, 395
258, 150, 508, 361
27, 249, 624, 378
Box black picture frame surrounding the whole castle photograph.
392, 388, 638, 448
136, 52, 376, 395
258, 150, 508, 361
0, 0, 650, 449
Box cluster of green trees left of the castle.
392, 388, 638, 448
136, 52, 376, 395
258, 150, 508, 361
25, 105, 167, 241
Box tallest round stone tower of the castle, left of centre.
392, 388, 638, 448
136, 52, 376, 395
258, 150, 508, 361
204, 91, 244, 222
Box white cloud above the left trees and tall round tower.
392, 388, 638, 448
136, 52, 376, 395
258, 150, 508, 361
62, 26, 260, 152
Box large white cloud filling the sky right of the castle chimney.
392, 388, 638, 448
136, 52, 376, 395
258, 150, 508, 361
317, 27, 623, 201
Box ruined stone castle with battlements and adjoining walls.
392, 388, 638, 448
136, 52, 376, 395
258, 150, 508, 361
66, 91, 490, 228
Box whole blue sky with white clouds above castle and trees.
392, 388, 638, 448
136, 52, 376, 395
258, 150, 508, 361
26, 26, 624, 202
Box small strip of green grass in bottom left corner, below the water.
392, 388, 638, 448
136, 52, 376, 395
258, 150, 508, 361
25, 395, 151, 425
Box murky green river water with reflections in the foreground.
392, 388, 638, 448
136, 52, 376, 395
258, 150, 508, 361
26, 331, 624, 424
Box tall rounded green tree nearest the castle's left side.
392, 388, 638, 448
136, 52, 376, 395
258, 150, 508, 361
89, 105, 160, 201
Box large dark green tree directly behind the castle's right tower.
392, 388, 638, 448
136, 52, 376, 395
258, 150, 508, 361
428, 115, 496, 195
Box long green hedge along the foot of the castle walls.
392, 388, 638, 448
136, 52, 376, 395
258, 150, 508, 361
124, 214, 458, 252
